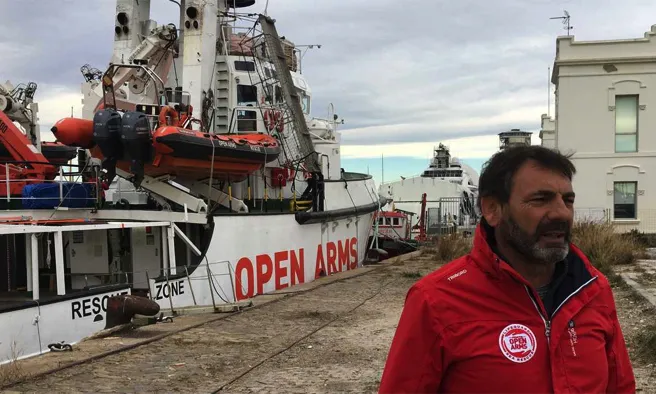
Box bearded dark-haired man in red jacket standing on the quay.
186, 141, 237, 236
380, 146, 635, 393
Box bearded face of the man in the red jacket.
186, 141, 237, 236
488, 161, 574, 264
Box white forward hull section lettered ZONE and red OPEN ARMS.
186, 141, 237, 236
150, 213, 372, 310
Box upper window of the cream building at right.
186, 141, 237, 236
615, 95, 638, 152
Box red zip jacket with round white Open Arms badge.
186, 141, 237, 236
379, 225, 635, 393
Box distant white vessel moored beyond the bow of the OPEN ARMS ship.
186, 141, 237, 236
378, 144, 478, 236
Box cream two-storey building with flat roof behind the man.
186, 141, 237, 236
540, 25, 656, 232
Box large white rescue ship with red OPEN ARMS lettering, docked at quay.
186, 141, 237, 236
0, 0, 386, 363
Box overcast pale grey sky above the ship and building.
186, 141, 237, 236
0, 0, 656, 179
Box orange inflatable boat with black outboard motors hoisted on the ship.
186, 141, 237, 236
52, 112, 281, 182
